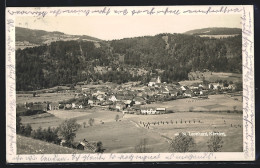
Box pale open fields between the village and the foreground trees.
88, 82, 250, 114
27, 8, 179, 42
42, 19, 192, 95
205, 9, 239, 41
18, 95, 243, 153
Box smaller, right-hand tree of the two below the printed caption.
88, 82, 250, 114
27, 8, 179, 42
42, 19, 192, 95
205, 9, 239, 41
207, 132, 223, 152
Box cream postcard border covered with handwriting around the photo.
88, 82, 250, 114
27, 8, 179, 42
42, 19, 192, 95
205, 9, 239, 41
6, 5, 255, 163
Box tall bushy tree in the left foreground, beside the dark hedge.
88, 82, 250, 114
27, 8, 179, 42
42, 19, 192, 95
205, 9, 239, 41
58, 119, 80, 146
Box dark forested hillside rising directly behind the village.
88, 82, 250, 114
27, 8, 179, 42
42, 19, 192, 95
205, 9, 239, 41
16, 34, 242, 90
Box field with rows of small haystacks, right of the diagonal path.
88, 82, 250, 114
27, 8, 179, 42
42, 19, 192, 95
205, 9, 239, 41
124, 112, 243, 152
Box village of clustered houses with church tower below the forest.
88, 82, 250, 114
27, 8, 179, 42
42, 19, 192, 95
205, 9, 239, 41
17, 76, 242, 115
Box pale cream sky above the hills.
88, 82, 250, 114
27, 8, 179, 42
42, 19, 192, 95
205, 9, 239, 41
15, 14, 241, 40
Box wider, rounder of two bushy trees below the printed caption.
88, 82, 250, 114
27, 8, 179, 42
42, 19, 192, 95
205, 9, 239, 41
169, 133, 195, 152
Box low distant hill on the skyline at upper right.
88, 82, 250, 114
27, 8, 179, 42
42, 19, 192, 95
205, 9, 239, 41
184, 27, 242, 35
